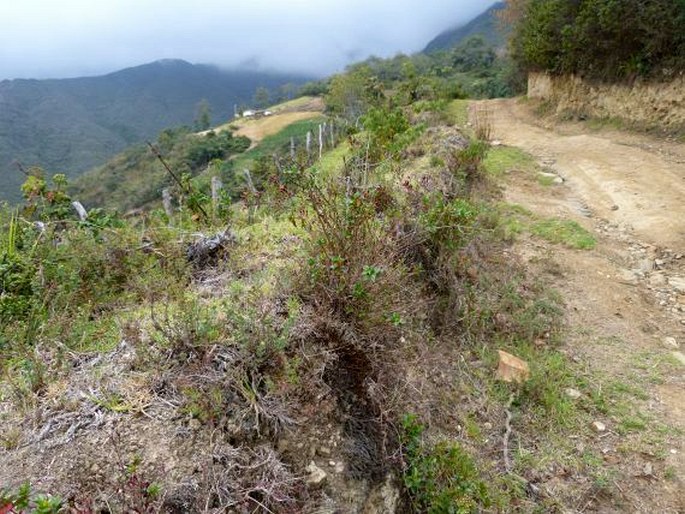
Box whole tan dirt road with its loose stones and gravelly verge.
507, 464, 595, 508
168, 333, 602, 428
472, 100, 685, 514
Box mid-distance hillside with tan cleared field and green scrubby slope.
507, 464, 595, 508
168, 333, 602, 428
71, 97, 323, 212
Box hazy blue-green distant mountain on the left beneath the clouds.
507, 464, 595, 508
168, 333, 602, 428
0, 60, 309, 201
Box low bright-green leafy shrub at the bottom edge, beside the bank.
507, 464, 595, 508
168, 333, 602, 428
402, 414, 490, 514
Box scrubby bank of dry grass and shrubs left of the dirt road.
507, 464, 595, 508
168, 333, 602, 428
0, 34, 680, 513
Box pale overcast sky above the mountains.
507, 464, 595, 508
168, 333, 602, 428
0, 0, 494, 80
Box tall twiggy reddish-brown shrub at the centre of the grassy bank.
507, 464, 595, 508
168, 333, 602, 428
296, 171, 416, 345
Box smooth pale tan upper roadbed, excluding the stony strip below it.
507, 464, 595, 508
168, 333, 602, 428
488, 100, 685, 253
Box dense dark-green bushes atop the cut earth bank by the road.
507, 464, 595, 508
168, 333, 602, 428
509, 0, 685, 80
